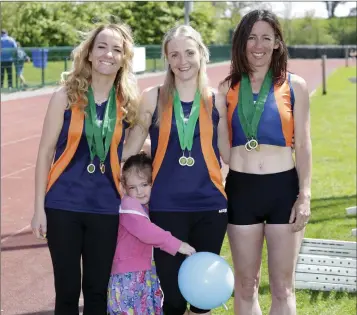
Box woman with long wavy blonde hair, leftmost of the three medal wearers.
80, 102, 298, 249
31, 24, 138, 315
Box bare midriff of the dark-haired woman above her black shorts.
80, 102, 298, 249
229, 144, 295, 174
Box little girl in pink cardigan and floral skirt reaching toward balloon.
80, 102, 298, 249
108, 153, 195, 315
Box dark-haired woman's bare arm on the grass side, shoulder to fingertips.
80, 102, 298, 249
290, 75, 312, 231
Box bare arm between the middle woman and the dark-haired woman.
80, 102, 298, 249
216, 86, 231, 164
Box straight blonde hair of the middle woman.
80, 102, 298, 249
156, 25, 211, 125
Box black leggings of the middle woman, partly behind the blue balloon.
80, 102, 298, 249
150, 209, 228, 315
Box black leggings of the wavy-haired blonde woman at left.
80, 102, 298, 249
46, 209, 119, 315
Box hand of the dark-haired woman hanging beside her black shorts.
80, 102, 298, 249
289, 195, 311, 232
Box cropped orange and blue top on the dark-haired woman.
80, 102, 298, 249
227, 73, 295, 147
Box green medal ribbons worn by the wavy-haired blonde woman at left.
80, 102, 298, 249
85, 86, 117, 163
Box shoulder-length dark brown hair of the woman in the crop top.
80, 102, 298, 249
222, 10, 288, 88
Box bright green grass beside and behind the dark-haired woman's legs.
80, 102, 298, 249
213, 67, 356, 315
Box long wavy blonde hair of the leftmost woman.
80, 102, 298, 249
61, 23, 139, 126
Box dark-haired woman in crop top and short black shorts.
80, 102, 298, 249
219, 10, 311, 315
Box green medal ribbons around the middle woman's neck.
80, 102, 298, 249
174, 90, 201, 151
